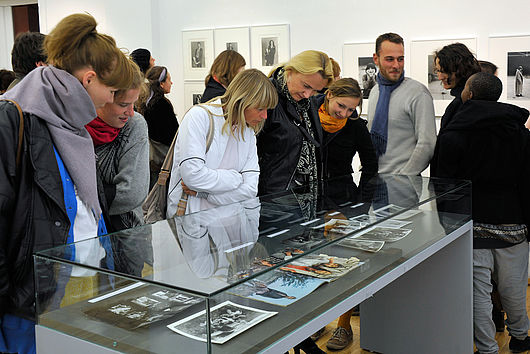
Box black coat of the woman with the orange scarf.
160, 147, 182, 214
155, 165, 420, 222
311, 95, 378, 178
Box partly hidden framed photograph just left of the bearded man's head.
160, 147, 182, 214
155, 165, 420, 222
342, 42, 379, 115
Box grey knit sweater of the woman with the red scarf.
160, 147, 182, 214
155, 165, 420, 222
95, 113, 149, 227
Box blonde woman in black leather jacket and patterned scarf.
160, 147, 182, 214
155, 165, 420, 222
258, 50, 333, 195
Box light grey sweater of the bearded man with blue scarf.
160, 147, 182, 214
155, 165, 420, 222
368, 77, 436, 175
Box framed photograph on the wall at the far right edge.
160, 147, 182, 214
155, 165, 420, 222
489, 35, 530, 109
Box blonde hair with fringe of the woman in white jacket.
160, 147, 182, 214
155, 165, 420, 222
207, 69, 278, 139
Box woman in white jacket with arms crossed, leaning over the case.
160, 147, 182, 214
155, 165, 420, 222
167, 69, 278, 214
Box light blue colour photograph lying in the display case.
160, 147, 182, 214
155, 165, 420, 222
231, 270, 326, 306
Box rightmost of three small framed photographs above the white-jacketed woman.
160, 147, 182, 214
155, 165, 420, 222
250, 25, 291, 75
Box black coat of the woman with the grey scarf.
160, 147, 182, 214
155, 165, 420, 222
0, 102, 70, 320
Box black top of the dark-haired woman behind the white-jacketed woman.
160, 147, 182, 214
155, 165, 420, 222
144, 97, 179, 146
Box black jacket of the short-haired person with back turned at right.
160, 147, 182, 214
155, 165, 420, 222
438, 100, 530, 245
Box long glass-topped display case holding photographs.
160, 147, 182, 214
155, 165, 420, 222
34, 175, 472, 353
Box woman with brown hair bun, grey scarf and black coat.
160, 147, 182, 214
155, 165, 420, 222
0, 14, 133, 354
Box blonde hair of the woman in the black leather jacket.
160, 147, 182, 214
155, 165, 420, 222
269, 50, 334, 86
